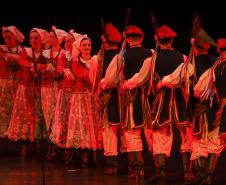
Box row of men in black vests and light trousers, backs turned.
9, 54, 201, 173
100, 21, 226, 184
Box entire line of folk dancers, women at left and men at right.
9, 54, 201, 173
1, 20, 225, 184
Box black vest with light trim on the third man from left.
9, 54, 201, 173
152, 49, 189, 127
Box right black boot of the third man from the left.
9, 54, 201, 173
182, 152, 194, 185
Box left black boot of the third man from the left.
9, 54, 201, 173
148, 154, 166, 183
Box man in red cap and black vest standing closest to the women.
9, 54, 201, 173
99, 23, 122, 174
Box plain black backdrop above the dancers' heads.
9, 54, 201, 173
0, 0, 226, 54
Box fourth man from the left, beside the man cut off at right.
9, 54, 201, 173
190, 28, 217, 183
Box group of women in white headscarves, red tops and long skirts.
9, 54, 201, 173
0, 26, 100, 165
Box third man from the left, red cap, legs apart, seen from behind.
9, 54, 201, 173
149, 25, 193, 182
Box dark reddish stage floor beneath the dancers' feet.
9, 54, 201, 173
0, 138, 226, 185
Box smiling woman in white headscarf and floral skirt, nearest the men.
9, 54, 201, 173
66, 35, 100, 166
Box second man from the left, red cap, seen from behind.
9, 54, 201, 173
120, 25, 151, 177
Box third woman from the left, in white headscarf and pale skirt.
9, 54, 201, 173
41, 26, 71, 159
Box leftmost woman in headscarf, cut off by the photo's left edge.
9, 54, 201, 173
0, 26, 24, 137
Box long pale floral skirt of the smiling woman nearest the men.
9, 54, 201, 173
66, 92, 97, 150
